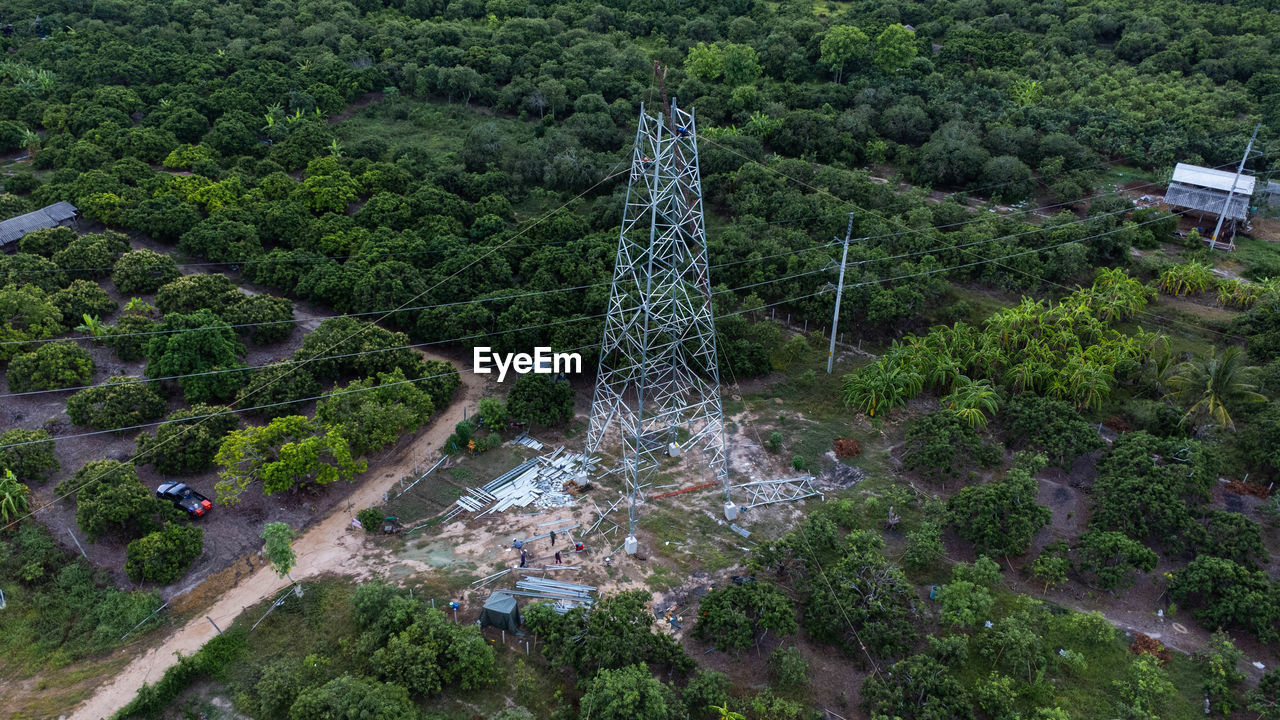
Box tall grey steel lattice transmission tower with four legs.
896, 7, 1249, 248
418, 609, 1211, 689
586, 100, 737, 552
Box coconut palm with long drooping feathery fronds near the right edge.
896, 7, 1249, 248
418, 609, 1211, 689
1169, 345, 1267, 429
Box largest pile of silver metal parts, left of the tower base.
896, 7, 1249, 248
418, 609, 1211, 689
444, 445, 599, 521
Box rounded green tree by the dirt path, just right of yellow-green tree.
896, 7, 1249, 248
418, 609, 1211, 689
316, 368, 437, 455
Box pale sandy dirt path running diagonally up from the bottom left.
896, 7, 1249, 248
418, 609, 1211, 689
69, 354, 484, 720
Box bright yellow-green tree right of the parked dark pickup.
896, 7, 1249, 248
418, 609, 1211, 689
215, 415, 367, 505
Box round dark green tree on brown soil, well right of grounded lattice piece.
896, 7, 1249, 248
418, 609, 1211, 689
947, 455, 1052, 555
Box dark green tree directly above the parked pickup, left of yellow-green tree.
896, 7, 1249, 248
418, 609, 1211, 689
137, 404, 239, 475
